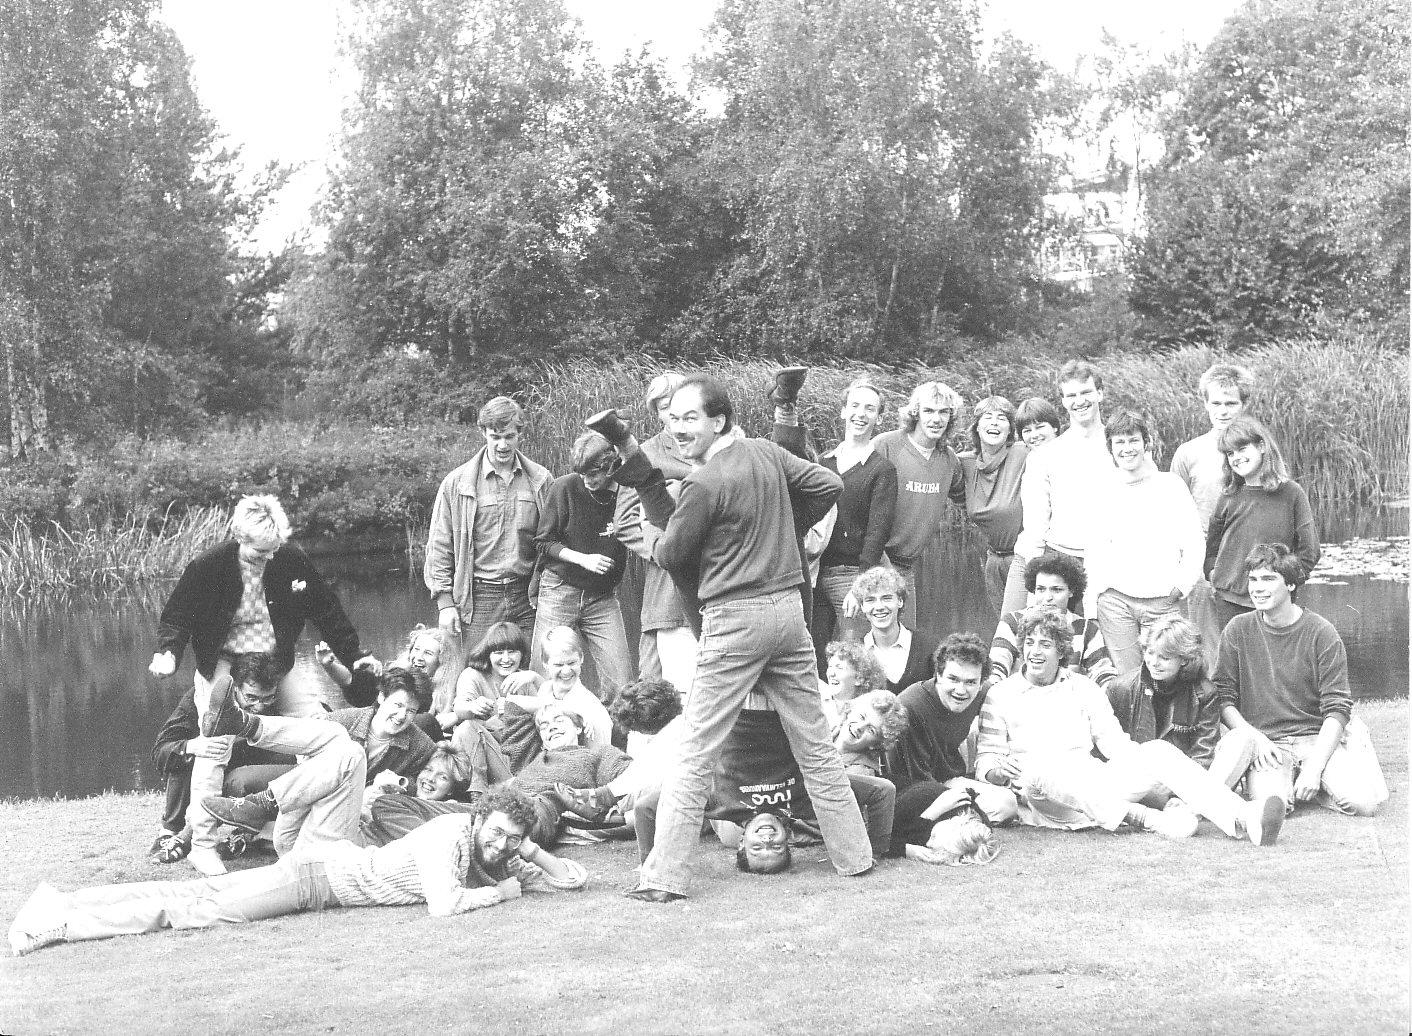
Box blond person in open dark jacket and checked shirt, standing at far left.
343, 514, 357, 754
148, 495, 381, 874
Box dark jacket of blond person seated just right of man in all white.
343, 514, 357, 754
1104, 663, 1221, 768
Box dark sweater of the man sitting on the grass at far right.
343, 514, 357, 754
1216, 608, 1353, 738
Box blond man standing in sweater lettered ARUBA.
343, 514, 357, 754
873, 381, 966, 627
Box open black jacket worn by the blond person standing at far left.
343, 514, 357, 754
157, 539, 369, 680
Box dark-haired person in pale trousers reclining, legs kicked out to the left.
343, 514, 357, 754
201, 668, 433, 855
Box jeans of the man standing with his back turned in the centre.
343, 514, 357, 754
641, 587, 873, 895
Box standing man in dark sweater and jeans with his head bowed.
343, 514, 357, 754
534, 432, 633, 701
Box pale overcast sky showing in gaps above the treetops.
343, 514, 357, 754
162, 0, 1238, 247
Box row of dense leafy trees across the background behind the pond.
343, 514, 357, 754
0, 0, 1408, 456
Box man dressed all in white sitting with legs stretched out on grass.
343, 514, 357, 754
976, 608, 1285, 845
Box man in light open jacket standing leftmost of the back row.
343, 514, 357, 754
422, 395, 554, 645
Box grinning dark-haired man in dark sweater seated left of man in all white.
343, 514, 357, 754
888, 632, 1015, 829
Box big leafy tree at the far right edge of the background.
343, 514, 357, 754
1132, 0, 1412, 344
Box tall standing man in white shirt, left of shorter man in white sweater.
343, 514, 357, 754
1015, 360, 1113, 615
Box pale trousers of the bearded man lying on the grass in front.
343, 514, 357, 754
55, 858, 339, 943
